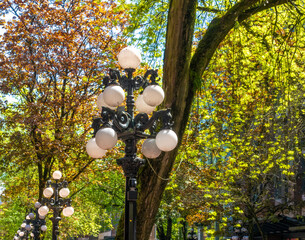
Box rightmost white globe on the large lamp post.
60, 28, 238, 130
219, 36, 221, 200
156, 129, 178, 152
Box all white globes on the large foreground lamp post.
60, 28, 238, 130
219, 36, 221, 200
86, 47, 178, 158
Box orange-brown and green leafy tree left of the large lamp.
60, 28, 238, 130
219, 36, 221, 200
0, 0, 127, 236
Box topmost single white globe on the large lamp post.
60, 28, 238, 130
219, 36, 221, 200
118, 47, 142, 69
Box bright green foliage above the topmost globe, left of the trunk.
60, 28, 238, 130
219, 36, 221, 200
117, 0, 169, 68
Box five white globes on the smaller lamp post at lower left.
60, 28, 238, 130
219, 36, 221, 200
37, 171, 74, 217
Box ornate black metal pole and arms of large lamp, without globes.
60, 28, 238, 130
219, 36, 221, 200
87, 47, 177, 240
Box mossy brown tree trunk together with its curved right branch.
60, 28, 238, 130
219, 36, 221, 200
116, 0, 287, 240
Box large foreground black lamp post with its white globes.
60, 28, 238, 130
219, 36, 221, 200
86, 47, 178, 240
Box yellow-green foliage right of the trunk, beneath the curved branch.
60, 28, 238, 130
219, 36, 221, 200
163, 5, 305, 238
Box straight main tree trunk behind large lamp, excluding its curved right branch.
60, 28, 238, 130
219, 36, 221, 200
137, 0, 197, 240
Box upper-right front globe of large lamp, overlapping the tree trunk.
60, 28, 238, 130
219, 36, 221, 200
143, 85, 164, 107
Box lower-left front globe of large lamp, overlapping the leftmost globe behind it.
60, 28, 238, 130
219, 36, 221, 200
95, 128, 118, 150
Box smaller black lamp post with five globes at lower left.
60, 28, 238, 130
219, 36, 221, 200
37, 171, 74, 240
